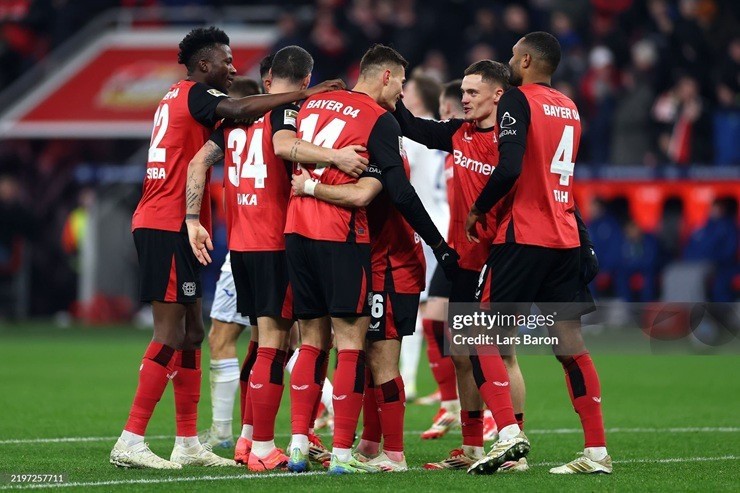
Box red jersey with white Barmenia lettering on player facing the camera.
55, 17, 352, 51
393, 103, 498, 270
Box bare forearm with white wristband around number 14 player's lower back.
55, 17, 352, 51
291, 169, 383, 208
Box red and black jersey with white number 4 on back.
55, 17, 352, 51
476, 84, 581, 248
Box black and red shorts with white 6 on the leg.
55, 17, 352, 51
366, 291, 419, 341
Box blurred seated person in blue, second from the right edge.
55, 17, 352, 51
612, 220, 659, 302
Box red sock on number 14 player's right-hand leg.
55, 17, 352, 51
333, 349, 365, 449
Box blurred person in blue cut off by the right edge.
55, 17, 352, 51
683, 199, 738, 302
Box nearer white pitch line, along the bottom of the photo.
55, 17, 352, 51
0, 455, 740, 490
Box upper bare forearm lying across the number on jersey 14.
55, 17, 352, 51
272, 130, 368, 178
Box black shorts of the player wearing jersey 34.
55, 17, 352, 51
231, 250, 293, 325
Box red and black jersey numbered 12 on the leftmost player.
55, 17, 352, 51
131, 80, 228, 231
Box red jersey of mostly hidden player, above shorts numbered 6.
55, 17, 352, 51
363, 156, 426, 294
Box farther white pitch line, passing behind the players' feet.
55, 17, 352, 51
0, 426, 740, 445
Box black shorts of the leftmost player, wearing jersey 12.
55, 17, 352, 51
134, 224, 201, 303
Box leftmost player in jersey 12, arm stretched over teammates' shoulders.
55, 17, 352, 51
110, 27, 343, 469
